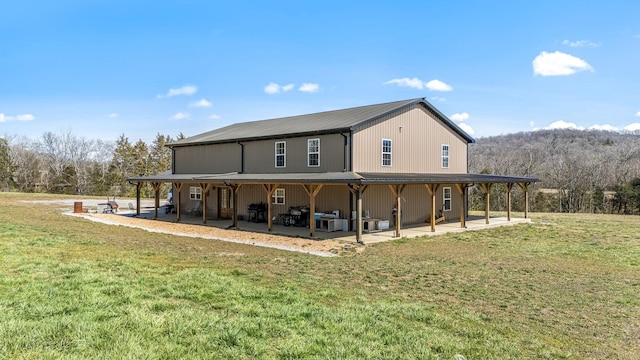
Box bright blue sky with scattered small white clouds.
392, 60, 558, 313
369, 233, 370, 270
0, 0, 640, 141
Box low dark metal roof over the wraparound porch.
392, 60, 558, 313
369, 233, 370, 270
129, 171, 540, 184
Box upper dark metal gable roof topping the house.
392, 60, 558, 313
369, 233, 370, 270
168, 98, 475, 147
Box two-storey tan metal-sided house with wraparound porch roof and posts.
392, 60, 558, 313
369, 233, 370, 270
130, 98, 538, 241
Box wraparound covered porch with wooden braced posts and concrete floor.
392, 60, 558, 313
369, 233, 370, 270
129, 172, 538, 243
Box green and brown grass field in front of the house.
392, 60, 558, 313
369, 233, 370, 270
0, 193, 640, 360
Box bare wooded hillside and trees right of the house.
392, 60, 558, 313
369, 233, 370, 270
469, 129, 640, 214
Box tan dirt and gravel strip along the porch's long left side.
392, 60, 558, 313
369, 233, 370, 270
70, 213, 364, 256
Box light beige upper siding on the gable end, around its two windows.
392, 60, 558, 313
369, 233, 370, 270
353, 108, 467, 173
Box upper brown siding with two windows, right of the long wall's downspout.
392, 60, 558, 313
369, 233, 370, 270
245, 134, 349, 174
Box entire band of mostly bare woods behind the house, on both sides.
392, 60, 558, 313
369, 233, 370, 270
0, 130, 640, 214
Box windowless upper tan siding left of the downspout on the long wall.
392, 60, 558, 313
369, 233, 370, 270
174, 144, 241, 174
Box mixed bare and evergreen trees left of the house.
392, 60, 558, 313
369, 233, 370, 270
0, 131, 184, 197
